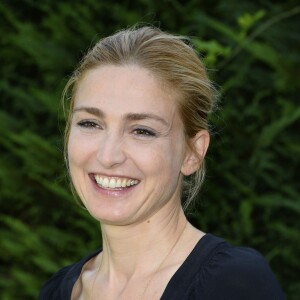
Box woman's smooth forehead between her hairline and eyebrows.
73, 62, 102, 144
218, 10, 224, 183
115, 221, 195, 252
74, 65, 183, 116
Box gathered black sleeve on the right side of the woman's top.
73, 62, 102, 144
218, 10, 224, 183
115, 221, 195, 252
197, 247, 286, 300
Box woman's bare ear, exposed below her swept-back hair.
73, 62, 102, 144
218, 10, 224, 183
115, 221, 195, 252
181, 130, 209, 176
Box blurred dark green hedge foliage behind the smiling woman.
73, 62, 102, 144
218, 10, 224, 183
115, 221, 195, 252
0, 0, 300, 300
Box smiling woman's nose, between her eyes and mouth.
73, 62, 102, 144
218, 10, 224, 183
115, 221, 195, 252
97, 134, 126, 169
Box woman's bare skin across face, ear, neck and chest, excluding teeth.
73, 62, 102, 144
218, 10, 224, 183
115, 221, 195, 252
68, 65, 209, 299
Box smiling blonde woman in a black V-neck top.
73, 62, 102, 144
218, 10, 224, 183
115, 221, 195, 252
40, 27, 284, 300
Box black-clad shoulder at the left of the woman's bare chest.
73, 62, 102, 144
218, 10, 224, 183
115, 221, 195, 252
38, 250, 100, 300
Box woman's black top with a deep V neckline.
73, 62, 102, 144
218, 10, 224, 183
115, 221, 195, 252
39, 234, 286, 300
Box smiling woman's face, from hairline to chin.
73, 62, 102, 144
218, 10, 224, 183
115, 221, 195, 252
68, 65, 193, 225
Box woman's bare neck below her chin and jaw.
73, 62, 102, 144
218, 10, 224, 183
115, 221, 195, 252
101, 200, 187, 280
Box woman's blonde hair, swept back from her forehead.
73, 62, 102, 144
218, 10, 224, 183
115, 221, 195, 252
63, 26, 214, 208
